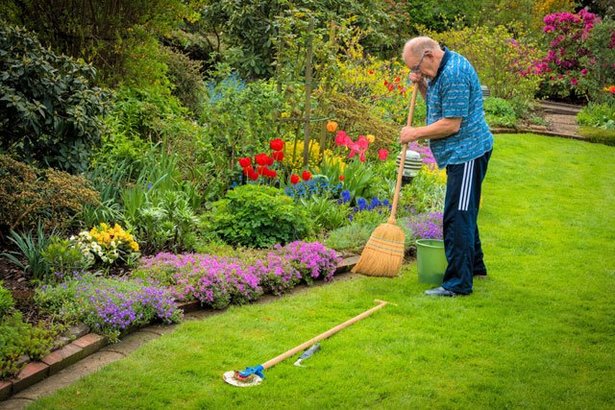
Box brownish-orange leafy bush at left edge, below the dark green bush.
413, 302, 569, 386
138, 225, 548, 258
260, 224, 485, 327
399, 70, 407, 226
0, 154, 99, 235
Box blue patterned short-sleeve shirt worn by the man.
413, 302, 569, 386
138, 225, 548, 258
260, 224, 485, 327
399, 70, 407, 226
426, 48, 493, 168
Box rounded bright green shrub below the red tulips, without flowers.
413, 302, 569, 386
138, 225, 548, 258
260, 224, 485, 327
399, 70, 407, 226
211, 185, 311, 248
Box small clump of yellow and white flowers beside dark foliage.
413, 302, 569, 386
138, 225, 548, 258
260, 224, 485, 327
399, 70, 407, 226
70, 222, 139, 266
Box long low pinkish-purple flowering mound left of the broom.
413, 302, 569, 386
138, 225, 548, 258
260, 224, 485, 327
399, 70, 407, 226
133, 241, 339, 302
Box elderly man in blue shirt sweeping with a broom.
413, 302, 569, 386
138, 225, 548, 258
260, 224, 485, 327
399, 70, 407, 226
400, 37, 493, 296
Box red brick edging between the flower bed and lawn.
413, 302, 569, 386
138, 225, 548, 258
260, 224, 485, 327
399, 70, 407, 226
0, 256, 359, 402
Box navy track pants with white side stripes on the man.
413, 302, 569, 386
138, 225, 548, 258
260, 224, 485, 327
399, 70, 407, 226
442, 151, 492, 295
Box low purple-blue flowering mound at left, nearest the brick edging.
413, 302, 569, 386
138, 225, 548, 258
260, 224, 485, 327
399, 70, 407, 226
35, 274, 181, 341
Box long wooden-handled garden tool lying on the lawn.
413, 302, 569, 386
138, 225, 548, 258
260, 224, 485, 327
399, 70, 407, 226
223, 300, 389, 387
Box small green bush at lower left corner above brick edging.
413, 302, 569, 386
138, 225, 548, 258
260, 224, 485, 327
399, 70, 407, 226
0, 312, 54, 379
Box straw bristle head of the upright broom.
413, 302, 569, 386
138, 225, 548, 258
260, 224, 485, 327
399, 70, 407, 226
352, 222, 405, 277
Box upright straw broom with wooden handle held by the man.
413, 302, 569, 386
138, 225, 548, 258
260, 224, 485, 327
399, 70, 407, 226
352, 84, 419, 276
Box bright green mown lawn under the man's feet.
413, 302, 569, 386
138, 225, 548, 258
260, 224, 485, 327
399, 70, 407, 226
33, 135, 615, 409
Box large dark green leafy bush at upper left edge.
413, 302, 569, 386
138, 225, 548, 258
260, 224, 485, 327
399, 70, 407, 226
0, 22, 108, 172
